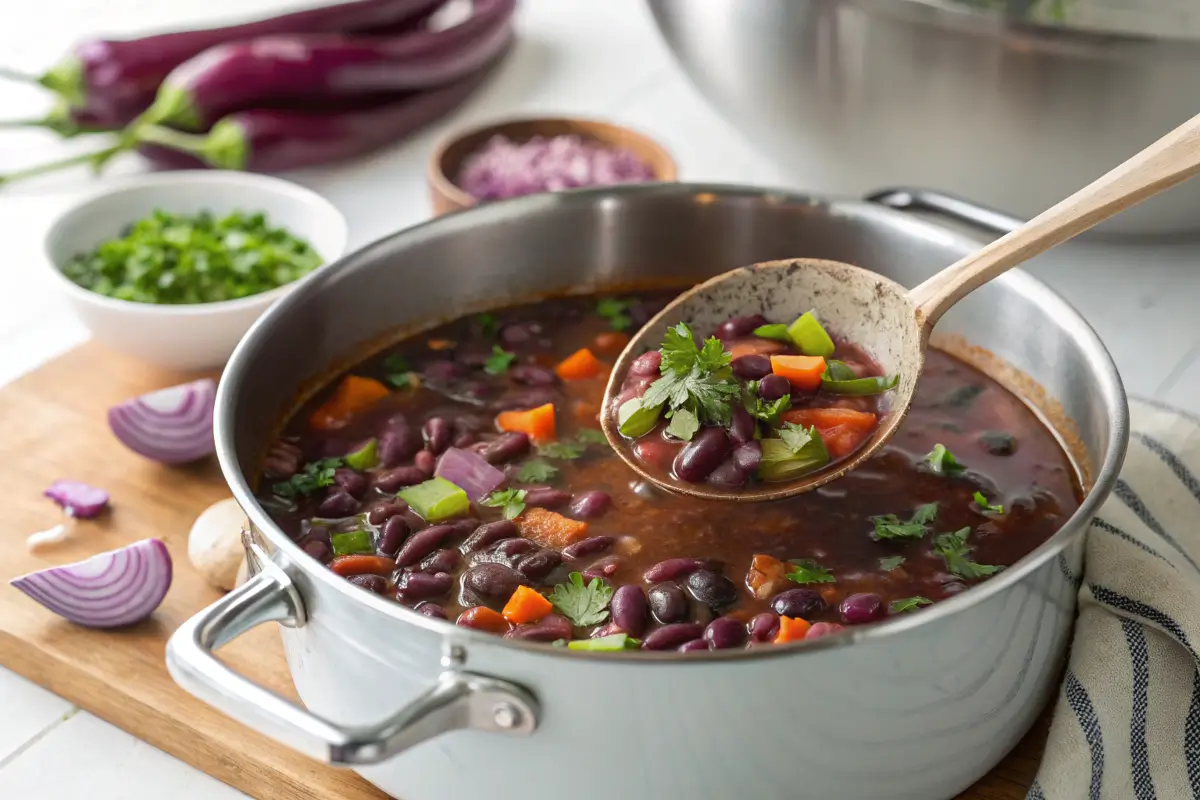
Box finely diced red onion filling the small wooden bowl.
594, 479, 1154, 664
458, 136, 654, 200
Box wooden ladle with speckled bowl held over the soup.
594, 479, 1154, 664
600, 116, 1200, 501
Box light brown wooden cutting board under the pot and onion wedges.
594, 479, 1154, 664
0, 343, 1049, 800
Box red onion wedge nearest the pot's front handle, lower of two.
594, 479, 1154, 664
8, 539, 172, 627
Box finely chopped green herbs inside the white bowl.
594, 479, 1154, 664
62, 210, 322, 305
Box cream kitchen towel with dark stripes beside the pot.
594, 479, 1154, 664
1027, 399, 1200, 800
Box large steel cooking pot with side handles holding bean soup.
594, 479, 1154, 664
167, 184, 1128, 800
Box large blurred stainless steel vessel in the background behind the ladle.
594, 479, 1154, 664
647, 0, 1200, 234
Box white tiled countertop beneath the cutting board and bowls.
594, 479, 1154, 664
0, 0, 1200, 800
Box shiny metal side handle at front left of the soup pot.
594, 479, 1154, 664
167, 547, 539, 766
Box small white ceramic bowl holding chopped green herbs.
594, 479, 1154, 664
44, 170, 348, 371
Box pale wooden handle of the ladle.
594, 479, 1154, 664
908, 110, 1200, 331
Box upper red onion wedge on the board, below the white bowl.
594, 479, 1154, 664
108, 378, 217, 464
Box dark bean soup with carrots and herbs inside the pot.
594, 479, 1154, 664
259, 293, 1081, 651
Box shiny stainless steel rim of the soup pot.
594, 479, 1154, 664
214, 182, 1129, 664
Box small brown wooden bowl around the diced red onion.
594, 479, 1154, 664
426, 118, 676, 216
